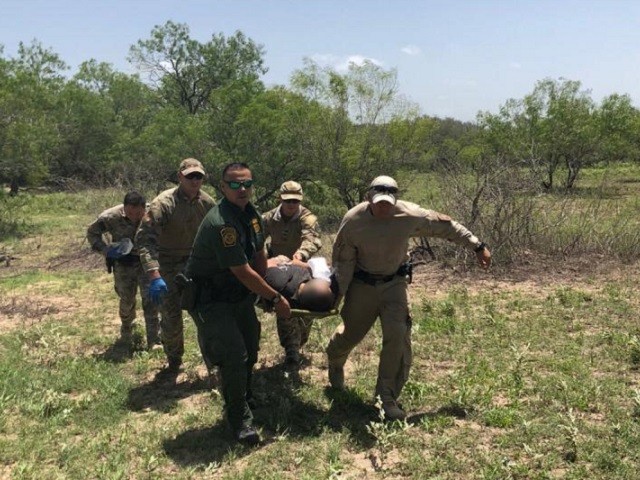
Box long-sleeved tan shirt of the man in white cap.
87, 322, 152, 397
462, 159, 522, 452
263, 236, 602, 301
333, 200, 480, 294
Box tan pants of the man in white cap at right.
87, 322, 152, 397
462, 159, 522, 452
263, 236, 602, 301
327, 277, 412, 401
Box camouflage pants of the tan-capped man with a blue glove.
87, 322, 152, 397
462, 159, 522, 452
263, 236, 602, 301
160, 258, 187, 359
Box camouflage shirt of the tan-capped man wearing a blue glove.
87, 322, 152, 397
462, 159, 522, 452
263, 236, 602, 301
135, 187, 215, 272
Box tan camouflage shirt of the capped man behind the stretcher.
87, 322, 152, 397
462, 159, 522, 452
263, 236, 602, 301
262, 206, 322, 261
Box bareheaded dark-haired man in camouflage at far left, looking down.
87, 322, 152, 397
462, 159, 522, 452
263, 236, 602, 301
87, 191, 160, 348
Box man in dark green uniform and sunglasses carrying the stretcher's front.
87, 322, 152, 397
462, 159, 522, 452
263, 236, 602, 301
186, 163, 291, 445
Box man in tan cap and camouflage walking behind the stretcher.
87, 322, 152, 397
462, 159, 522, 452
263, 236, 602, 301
262, 181, 322, 366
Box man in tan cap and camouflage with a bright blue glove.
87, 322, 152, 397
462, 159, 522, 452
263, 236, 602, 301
136, 158, 214, 371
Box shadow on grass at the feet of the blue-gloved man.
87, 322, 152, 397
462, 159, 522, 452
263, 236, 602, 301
127, 369, 208, 412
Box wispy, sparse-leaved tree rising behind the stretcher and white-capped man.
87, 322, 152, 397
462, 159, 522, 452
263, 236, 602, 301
292, 60, 417, 208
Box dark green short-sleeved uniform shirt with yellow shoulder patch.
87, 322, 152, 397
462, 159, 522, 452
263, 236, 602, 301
186, 198, 264, 298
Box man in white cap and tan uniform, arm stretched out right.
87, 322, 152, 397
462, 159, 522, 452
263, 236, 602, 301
327, 176, 491, 420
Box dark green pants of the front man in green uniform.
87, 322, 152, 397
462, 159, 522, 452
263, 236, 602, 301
190, 292, 261, 430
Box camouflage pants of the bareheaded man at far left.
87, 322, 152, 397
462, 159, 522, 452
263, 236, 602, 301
113, 262, 160, 342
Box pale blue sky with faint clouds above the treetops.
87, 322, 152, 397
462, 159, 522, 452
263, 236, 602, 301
0, 0, 640, 120
